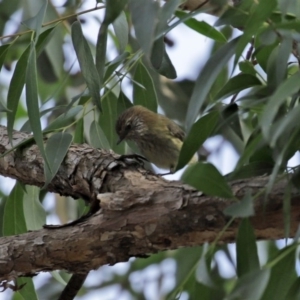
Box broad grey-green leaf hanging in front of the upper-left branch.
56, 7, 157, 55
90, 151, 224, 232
44, 132, 73, 187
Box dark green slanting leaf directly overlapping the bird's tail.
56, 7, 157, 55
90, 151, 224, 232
176, 111, 219, 170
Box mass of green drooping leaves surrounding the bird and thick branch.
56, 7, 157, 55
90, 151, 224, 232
0, 0, 300, 300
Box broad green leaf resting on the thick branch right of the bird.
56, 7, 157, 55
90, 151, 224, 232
182, 162, 233, 198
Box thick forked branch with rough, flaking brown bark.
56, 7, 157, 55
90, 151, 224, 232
0, 127, 300, 281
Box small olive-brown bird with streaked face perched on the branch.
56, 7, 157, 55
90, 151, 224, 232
116, 105, 198, 173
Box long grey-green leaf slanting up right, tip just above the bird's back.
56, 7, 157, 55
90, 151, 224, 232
186, 38, 239, 130
